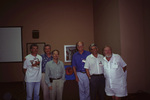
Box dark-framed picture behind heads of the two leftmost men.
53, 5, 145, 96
26, 42, 45, 55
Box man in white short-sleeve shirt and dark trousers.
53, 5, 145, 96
84, 44, 105, 100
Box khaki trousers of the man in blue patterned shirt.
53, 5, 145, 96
41, 73, 50, 100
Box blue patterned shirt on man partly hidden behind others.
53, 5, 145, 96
41, 54, 53, 73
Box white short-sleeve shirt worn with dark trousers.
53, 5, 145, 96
84, 54, 104, 75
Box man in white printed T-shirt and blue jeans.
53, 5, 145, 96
23, 44, 42, 100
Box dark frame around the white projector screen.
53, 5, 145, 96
0, 26, 23, 63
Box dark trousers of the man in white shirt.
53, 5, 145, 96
90, 75, 105, 100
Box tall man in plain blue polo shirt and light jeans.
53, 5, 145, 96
72, 41, 90, 100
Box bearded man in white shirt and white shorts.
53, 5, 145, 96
103, 46, 127, 100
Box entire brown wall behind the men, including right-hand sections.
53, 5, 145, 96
0, 0, 150, 93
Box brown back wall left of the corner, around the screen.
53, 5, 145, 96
0, 0, 94, 82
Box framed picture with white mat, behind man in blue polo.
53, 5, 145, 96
64, 45, 77, 62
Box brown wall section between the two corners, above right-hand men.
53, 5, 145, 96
93, 0, 121, 54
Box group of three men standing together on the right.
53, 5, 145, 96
72, 42, 127, 100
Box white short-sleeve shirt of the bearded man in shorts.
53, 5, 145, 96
104, 54, 127, 89
